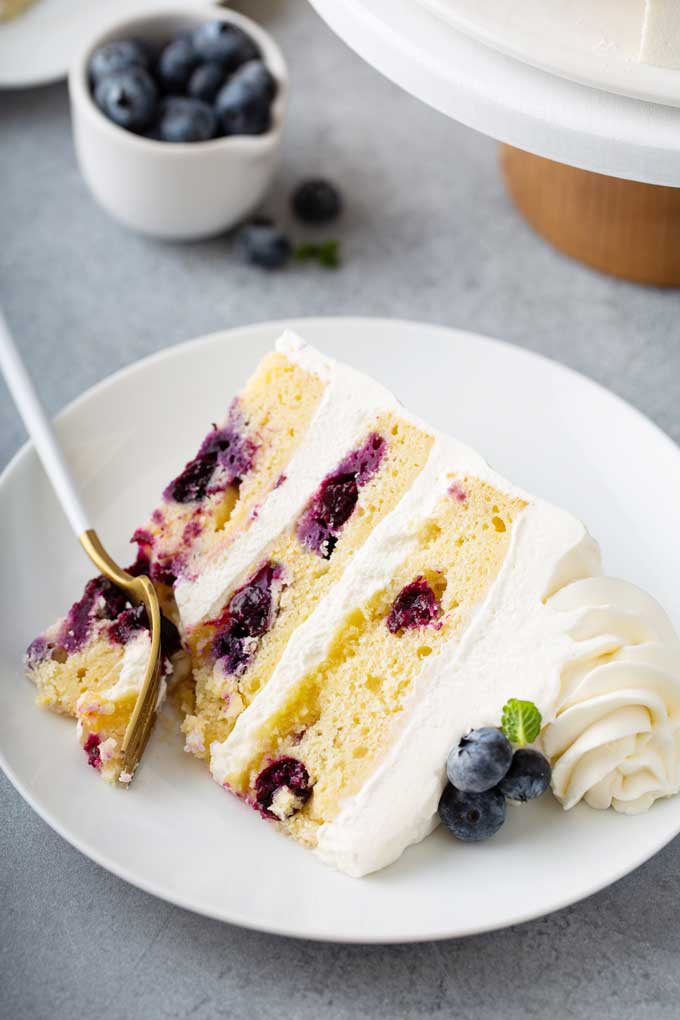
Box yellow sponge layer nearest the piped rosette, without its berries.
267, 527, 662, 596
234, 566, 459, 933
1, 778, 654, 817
227, 477, 525, 845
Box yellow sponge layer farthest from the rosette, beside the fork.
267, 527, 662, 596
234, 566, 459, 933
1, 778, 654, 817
137, 352, 325, 595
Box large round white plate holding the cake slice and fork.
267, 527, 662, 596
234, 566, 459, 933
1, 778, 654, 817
0, 318, 680, 941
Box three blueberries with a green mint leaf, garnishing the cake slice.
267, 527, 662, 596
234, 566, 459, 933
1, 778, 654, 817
438, 698, 551, 843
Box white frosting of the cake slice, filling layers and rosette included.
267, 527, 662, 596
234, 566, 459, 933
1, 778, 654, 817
204, 338, 680, 876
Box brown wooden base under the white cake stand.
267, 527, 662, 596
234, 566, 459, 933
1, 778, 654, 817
501, 145, 680, 287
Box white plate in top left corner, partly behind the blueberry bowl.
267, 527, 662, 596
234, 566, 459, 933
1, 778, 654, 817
0, 0, 207, 89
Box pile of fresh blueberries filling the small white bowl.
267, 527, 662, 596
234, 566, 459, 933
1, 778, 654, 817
89, 20, 277, 143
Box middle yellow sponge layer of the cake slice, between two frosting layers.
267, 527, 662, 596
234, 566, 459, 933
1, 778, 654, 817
182, 413, 433, 758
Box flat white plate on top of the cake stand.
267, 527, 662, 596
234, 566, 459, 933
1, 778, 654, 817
414, 0, 680, 106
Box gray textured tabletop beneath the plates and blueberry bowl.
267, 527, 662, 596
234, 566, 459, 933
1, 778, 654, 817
0, 0, 680, 1020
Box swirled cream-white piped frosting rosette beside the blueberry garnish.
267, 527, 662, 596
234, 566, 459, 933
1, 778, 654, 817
541, 577, 680, 814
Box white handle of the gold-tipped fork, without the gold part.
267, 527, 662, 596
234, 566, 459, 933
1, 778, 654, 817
0, 309, 91, 538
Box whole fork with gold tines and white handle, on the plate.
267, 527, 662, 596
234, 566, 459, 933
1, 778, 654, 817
0, 310, 161, 782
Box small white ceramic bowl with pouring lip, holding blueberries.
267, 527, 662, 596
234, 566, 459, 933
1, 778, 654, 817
68, 6, 287, 241
